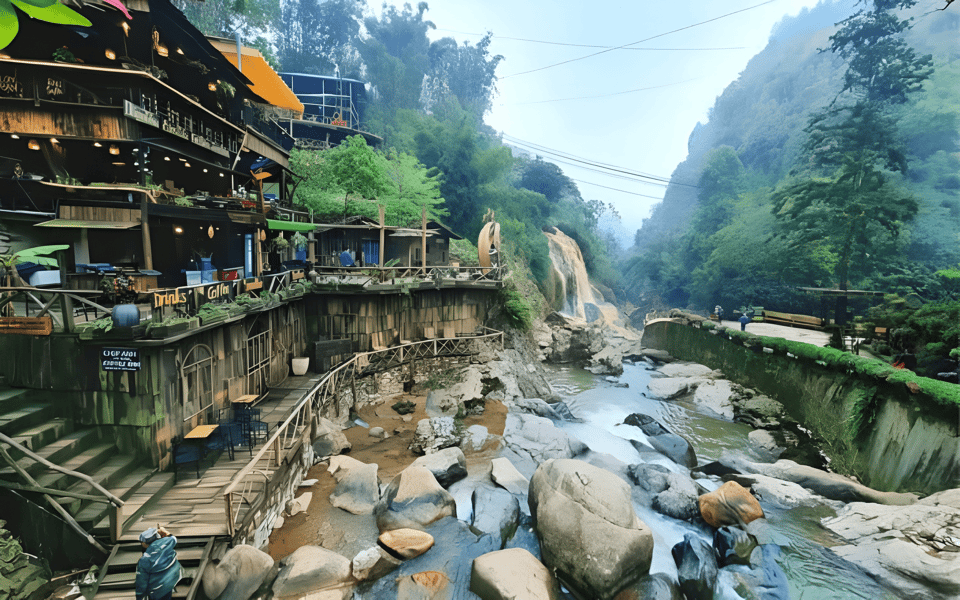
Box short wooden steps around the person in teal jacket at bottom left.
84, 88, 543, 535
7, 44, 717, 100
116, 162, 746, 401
88, 537, 219, 600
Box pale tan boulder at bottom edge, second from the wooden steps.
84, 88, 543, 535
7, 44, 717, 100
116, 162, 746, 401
273, 546, 351, 598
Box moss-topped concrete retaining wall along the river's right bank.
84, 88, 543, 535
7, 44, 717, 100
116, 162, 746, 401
643, 321, 960, 493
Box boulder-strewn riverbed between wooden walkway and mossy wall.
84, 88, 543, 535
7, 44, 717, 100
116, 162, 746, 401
197, 324, 960, 600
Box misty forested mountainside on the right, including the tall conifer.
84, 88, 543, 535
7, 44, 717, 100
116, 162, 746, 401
625, 0, 960, 311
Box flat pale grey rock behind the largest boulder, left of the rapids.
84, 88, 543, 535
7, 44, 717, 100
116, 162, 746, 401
501, 413, 587, 477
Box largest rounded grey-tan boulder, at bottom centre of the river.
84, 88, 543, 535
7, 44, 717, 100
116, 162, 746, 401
528, 459, 653, 600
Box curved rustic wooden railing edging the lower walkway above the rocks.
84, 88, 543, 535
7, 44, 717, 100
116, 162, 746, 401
223, 327, 503, 536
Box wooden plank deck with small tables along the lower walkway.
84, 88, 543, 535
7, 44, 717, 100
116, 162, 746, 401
120, 373, 321, 542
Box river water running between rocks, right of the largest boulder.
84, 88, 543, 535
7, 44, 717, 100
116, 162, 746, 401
546, 363, 897, 600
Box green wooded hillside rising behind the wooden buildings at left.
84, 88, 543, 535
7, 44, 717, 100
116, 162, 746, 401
174, 0, 618, 310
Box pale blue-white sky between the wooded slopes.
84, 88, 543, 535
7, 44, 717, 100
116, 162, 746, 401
371, 0, 818, 246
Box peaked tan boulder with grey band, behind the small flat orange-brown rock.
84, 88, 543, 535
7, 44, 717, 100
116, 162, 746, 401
373, 466, 457, 532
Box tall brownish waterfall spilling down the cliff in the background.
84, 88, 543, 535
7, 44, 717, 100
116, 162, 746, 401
544, 228, 604, 321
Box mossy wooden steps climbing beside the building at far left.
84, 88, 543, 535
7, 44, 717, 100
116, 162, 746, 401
0, 386, 173, 544
